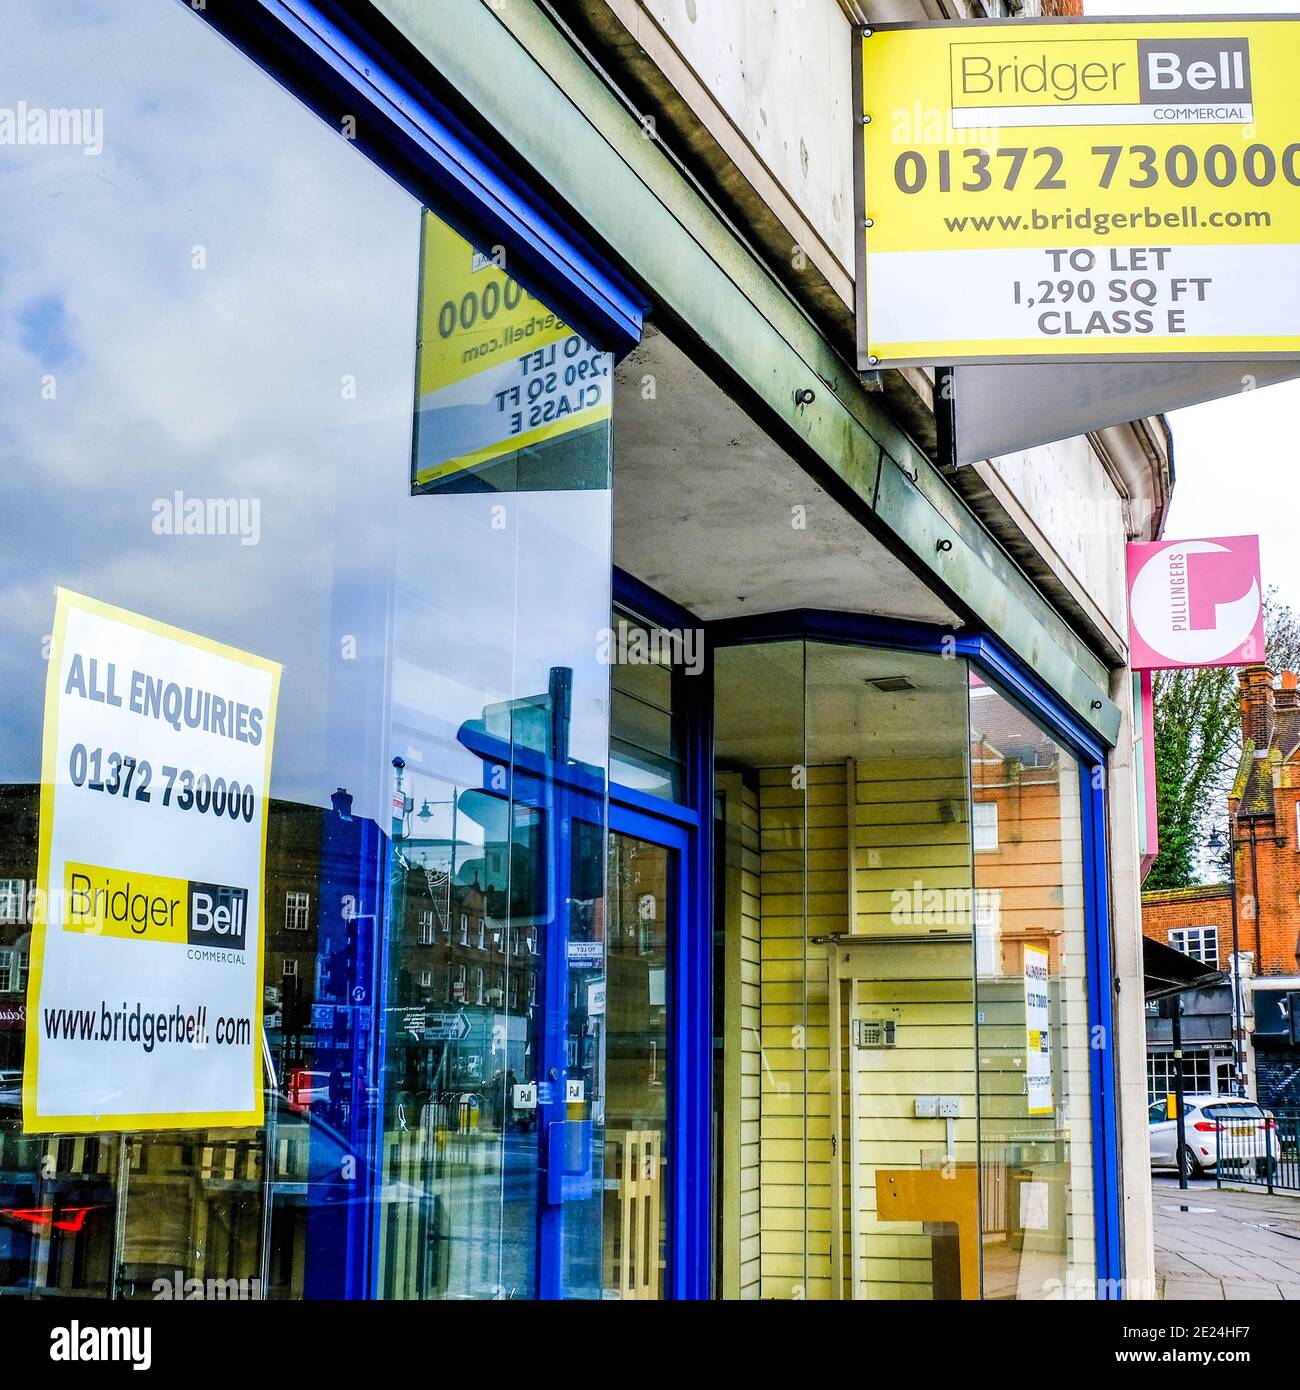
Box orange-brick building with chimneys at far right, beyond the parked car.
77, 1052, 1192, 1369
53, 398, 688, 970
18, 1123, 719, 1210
1141, 666, 1300, 1104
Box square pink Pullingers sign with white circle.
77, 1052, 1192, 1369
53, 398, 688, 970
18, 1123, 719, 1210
1128, 535, 1264, 671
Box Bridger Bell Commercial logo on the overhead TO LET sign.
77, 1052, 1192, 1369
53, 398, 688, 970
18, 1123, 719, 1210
950, 38, 1254, 128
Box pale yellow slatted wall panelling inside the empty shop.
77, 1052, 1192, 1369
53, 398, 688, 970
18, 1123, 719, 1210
759, 755, 975, 1298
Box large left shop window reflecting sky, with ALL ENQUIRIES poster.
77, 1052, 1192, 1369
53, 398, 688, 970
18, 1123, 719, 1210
0, 0, 610, 1301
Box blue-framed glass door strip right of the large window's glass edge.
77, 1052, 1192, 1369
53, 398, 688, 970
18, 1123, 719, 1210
603, 806, 684, 1300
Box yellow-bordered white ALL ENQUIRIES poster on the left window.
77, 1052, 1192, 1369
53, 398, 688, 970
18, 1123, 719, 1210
22, 589, 279, 1133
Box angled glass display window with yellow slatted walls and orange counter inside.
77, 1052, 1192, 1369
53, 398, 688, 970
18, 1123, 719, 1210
715, 639, 1096, 1300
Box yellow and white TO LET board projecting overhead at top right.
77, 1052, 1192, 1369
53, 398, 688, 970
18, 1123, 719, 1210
856, 18, 1300, 368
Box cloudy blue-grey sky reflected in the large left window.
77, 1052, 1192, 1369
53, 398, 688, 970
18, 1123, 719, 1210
0, 0, 609, 835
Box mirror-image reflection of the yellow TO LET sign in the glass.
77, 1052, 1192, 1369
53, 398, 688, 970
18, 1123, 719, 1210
412, 211, 613, 492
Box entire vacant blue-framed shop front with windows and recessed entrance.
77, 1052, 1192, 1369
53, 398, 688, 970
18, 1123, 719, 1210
0, 0, 1121, 1300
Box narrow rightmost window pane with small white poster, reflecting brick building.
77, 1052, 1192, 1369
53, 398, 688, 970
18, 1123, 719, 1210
970, 673, 1097, 1300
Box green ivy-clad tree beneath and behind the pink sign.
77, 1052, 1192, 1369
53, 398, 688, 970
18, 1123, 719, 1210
1144, 588, 1300, 888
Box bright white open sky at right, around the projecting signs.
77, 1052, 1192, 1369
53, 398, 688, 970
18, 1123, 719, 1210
1084, 0, 1300, 607
